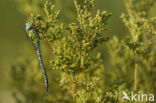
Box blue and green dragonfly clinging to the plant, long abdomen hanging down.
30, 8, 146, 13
25, 22, 48, 91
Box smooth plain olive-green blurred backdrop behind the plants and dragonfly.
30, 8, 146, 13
0, 0, 156, 103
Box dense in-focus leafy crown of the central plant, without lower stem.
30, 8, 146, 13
29, 0, 111, 74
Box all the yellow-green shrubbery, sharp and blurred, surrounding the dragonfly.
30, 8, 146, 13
6, 0, 156, 103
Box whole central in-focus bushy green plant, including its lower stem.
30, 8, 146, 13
11, 0, 111, 103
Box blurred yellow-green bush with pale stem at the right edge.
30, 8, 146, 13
108, 0, 156, 92
